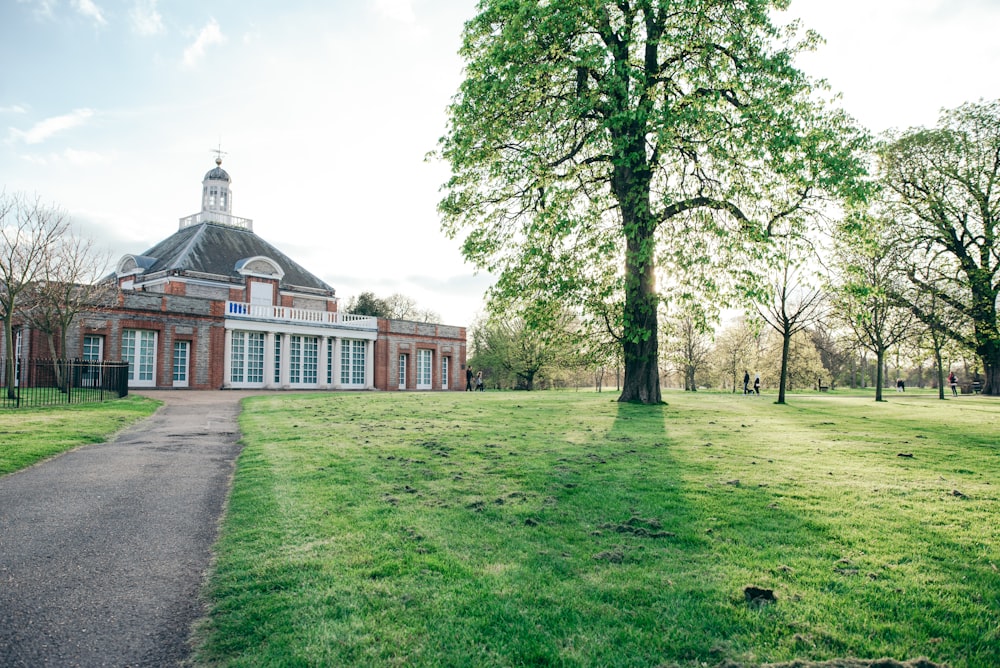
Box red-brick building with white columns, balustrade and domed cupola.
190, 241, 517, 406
0, 159, 466, 390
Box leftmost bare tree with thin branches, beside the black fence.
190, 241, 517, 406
0, 192, 69, 399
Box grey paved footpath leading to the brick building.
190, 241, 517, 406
0, 391, 262, 668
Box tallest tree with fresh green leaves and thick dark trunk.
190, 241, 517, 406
438, 0, 859, 403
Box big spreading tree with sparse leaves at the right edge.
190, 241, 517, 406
881, 101, 1000, 395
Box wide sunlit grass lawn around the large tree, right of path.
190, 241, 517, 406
196, 391, 1000, 668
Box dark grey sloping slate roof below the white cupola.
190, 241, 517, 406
131, 222, 334, 295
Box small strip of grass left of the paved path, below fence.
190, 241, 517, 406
0, 395, 160, 475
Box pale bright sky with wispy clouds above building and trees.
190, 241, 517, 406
0, 0, 1000, 326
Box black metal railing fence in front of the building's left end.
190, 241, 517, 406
0, 359, 128, 408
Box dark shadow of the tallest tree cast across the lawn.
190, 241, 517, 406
597, 405, 971, 666
